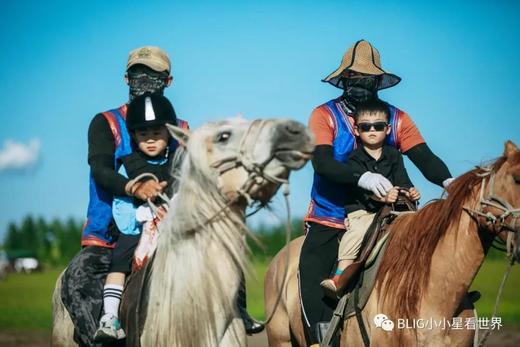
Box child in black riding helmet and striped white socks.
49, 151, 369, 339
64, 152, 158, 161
94, 93, 177, 341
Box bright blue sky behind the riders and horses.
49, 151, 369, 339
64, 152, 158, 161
0, 0, 520, 239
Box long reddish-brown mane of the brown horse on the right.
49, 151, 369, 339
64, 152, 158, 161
376, 156, 506, 318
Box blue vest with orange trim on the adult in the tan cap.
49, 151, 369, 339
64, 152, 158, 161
81, 105, 188, 248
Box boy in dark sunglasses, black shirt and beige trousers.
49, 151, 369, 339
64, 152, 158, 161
321, 99, 421, 298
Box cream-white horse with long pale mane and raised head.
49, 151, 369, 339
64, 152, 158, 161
52, 119, 314, 347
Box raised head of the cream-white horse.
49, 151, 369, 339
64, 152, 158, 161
169, 119, 314, 207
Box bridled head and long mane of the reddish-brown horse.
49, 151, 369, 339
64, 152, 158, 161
377, 141, 520, 317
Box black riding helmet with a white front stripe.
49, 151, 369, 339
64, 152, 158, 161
126, 93, 177, 131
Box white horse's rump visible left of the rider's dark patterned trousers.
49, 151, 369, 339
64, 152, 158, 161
51, 270, 77, 347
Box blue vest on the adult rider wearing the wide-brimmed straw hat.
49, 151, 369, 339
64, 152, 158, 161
304, 99, 402, 229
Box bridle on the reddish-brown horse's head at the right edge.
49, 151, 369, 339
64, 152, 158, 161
463, 166, 520, 258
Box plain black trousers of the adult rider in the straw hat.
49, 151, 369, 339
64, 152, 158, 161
299, 222, 345, 344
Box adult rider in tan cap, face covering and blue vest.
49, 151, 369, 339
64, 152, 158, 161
61, 46, 263, 346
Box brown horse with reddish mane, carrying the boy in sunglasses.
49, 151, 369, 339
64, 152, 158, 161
265, 141, 520, 347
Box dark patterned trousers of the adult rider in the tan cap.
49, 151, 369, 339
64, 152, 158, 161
61, 246, 112, 346
